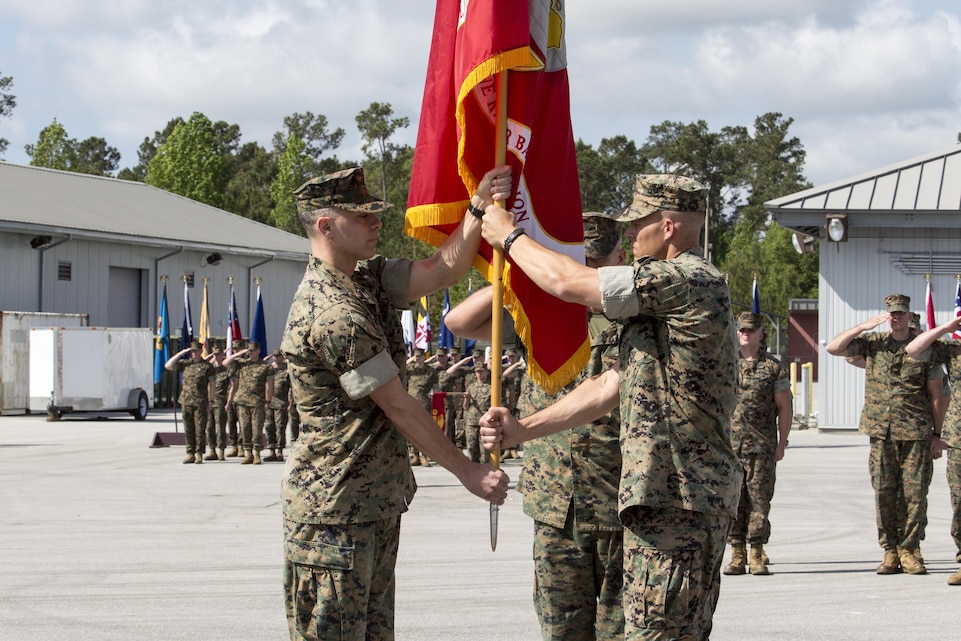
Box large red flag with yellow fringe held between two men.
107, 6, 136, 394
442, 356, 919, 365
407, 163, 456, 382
405, 0, 590, 392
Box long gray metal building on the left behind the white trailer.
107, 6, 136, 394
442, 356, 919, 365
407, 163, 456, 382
0, 163, 309, 349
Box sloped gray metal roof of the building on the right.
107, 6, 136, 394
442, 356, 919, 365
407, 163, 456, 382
764, 145, 961, 237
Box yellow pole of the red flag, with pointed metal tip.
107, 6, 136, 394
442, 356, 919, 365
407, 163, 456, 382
490, 71, 507, 551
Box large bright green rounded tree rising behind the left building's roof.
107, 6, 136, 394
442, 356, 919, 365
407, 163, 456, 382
146, 112, 230, 208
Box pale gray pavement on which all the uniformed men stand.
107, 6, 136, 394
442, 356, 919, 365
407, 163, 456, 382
0, 411, 961, 641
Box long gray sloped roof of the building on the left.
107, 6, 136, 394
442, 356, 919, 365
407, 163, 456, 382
0, 162, 309, 260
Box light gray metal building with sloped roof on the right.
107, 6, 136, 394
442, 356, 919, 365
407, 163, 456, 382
765, 145, 961, 429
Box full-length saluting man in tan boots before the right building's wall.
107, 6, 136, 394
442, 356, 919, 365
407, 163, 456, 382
827, 294, 943, 574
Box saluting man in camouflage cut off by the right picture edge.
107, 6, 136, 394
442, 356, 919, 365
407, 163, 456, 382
905, 316, 961, 585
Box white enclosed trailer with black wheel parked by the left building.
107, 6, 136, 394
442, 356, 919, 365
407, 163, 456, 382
30, 327, 154, 421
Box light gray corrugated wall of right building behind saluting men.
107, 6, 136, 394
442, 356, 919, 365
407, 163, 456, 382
818, 228, 961, 429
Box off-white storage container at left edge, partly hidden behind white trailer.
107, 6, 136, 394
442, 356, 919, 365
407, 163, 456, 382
0, 311, 90, 414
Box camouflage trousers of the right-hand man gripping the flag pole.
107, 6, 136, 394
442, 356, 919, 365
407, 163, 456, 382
621, 507, 731, 641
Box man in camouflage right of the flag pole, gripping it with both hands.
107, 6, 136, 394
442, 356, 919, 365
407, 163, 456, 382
483, 174, 743, 640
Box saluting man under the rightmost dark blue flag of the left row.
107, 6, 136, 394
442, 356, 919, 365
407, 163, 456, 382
226, 341, 274, 465
